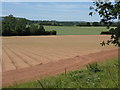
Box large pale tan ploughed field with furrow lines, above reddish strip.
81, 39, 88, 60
3, 36, 115, 71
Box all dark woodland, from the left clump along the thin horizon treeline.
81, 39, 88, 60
2, 15, 117, 36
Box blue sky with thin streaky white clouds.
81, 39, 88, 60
2, 2, 100, 21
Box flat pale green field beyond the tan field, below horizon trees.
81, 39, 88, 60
44, 26, 109, 35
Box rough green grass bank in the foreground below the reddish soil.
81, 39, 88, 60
6, 58, 118, 88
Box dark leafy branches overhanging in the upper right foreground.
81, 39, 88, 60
89, 0, 120, 47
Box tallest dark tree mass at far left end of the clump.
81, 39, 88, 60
2, 15, 27, 36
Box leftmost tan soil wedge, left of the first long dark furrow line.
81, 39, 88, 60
2, 49, 16, 72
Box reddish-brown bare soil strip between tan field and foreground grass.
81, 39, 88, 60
3, 50, 118, 85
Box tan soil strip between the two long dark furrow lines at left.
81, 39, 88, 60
4, 45, 29, 69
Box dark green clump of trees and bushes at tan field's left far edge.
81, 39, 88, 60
2, 15, 57, 36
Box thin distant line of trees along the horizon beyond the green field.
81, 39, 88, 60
29, 21, 117, 27
